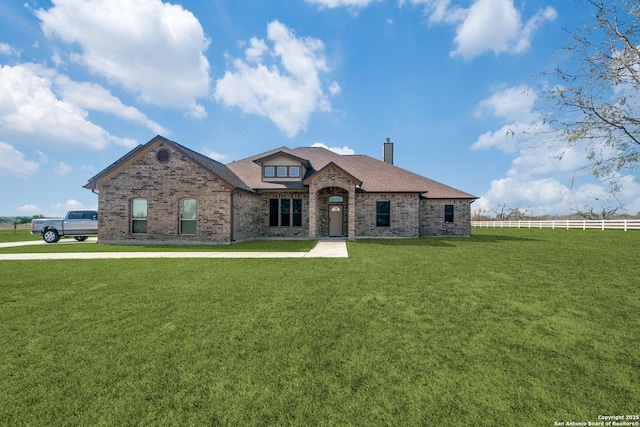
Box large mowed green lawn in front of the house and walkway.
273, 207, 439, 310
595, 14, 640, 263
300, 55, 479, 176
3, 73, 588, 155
0, 229, 640, 426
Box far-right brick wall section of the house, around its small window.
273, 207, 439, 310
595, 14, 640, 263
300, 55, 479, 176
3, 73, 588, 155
420, 199, 471, 237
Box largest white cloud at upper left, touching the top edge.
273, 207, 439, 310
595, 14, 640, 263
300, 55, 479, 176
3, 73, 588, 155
36, 0, 210, 113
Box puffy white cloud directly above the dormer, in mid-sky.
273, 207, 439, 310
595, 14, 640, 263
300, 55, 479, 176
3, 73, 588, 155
215, 21, 339, 137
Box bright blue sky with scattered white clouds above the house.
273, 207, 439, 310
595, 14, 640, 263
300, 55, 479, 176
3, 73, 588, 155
0, 0, 640, 216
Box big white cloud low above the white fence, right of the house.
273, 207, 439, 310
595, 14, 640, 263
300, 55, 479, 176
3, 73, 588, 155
472, 86, 640, 215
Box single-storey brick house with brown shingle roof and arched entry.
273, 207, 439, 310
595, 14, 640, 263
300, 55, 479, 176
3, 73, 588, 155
84, 136, 476, 243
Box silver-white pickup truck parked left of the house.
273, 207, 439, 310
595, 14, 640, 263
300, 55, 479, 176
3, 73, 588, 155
31, 210, 98, 243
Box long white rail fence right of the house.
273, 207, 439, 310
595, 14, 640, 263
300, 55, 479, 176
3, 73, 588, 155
471, 219, 640, 231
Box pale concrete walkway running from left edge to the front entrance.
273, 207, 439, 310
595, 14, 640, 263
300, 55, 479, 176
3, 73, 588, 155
0, 238, 349, 261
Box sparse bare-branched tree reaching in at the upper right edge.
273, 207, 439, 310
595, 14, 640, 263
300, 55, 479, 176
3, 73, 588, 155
546, 0, 640, 184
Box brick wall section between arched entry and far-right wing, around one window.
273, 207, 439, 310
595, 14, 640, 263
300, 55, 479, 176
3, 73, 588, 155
356, 193, 420, 237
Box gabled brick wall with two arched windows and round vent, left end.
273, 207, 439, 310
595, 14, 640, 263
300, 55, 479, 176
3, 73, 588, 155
98, 146, 231, 243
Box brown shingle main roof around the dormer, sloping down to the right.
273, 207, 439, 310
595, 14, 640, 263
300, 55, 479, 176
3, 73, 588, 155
227, 147, 476, 199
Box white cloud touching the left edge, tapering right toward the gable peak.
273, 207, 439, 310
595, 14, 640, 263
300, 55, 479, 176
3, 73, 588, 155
0, 64, 137, 149
